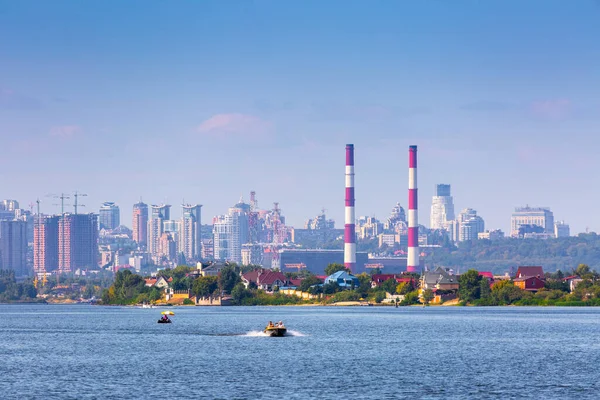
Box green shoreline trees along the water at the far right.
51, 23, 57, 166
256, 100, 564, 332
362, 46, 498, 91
458, 264, 600, 306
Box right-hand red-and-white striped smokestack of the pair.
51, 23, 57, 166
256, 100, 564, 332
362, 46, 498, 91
406, 146, 420, 272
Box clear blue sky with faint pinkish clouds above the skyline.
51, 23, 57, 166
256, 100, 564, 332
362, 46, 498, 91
0, 0, 600, 234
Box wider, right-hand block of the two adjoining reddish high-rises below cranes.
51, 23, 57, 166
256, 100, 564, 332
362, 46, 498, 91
58, 213, 98, 273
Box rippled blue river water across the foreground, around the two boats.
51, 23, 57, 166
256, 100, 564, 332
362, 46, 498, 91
0, 305, 600, 399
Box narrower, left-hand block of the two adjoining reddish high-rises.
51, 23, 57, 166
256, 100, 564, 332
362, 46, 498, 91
33, 214, 59, 274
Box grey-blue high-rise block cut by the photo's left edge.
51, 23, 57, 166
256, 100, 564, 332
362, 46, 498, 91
0, 221, 30, 277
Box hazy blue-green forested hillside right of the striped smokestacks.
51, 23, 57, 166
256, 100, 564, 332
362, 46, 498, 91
425, 233, 600, 274
